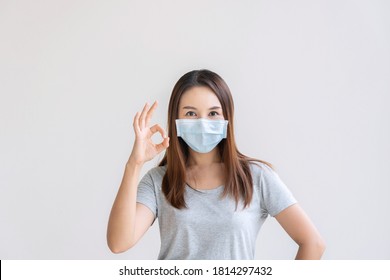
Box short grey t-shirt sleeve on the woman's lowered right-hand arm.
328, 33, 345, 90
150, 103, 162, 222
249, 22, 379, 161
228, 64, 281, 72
260, 165, 297, 217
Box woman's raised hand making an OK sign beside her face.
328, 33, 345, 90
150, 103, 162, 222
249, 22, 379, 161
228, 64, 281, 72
128, 101, 169, 165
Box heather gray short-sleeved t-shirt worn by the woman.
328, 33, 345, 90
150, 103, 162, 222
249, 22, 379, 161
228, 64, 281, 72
137, 163, 296, 260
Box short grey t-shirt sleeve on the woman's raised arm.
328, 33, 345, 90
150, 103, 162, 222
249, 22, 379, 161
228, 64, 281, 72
137, 172, 158, 218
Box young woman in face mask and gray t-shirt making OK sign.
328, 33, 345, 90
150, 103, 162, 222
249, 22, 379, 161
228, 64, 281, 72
107, 70, 325, 259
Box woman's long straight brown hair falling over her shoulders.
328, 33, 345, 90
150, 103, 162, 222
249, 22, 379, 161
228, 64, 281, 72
159, 70, 272, 209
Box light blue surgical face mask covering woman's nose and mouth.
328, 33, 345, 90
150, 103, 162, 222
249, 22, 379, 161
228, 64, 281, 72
176, 119, 228, 153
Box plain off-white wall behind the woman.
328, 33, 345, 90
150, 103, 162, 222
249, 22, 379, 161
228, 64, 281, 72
0, 0, 390, 259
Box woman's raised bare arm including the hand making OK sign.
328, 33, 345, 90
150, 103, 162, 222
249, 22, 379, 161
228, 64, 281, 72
107, 102, 169, 253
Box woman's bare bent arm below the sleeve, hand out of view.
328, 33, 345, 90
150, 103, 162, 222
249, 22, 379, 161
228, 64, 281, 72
275, 204, 325, 260
